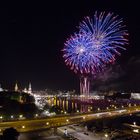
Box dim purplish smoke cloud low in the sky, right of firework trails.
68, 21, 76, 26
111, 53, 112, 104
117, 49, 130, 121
92, 56, 140, 92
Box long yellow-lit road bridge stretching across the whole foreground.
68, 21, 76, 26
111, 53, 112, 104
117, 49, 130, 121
0, 106, 140, 132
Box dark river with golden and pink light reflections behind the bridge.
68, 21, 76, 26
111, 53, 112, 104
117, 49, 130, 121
41, 96, 140, 113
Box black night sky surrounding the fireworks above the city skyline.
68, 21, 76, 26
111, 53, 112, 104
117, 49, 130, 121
0, 0, 140, 90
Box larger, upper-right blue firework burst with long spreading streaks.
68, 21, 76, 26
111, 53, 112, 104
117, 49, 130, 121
79, 12, 128, 60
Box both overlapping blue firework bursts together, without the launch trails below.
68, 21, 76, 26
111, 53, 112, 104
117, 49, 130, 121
63, 12, 128, 74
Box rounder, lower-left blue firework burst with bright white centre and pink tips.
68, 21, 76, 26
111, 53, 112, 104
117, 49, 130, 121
63, 34, 103, 74
